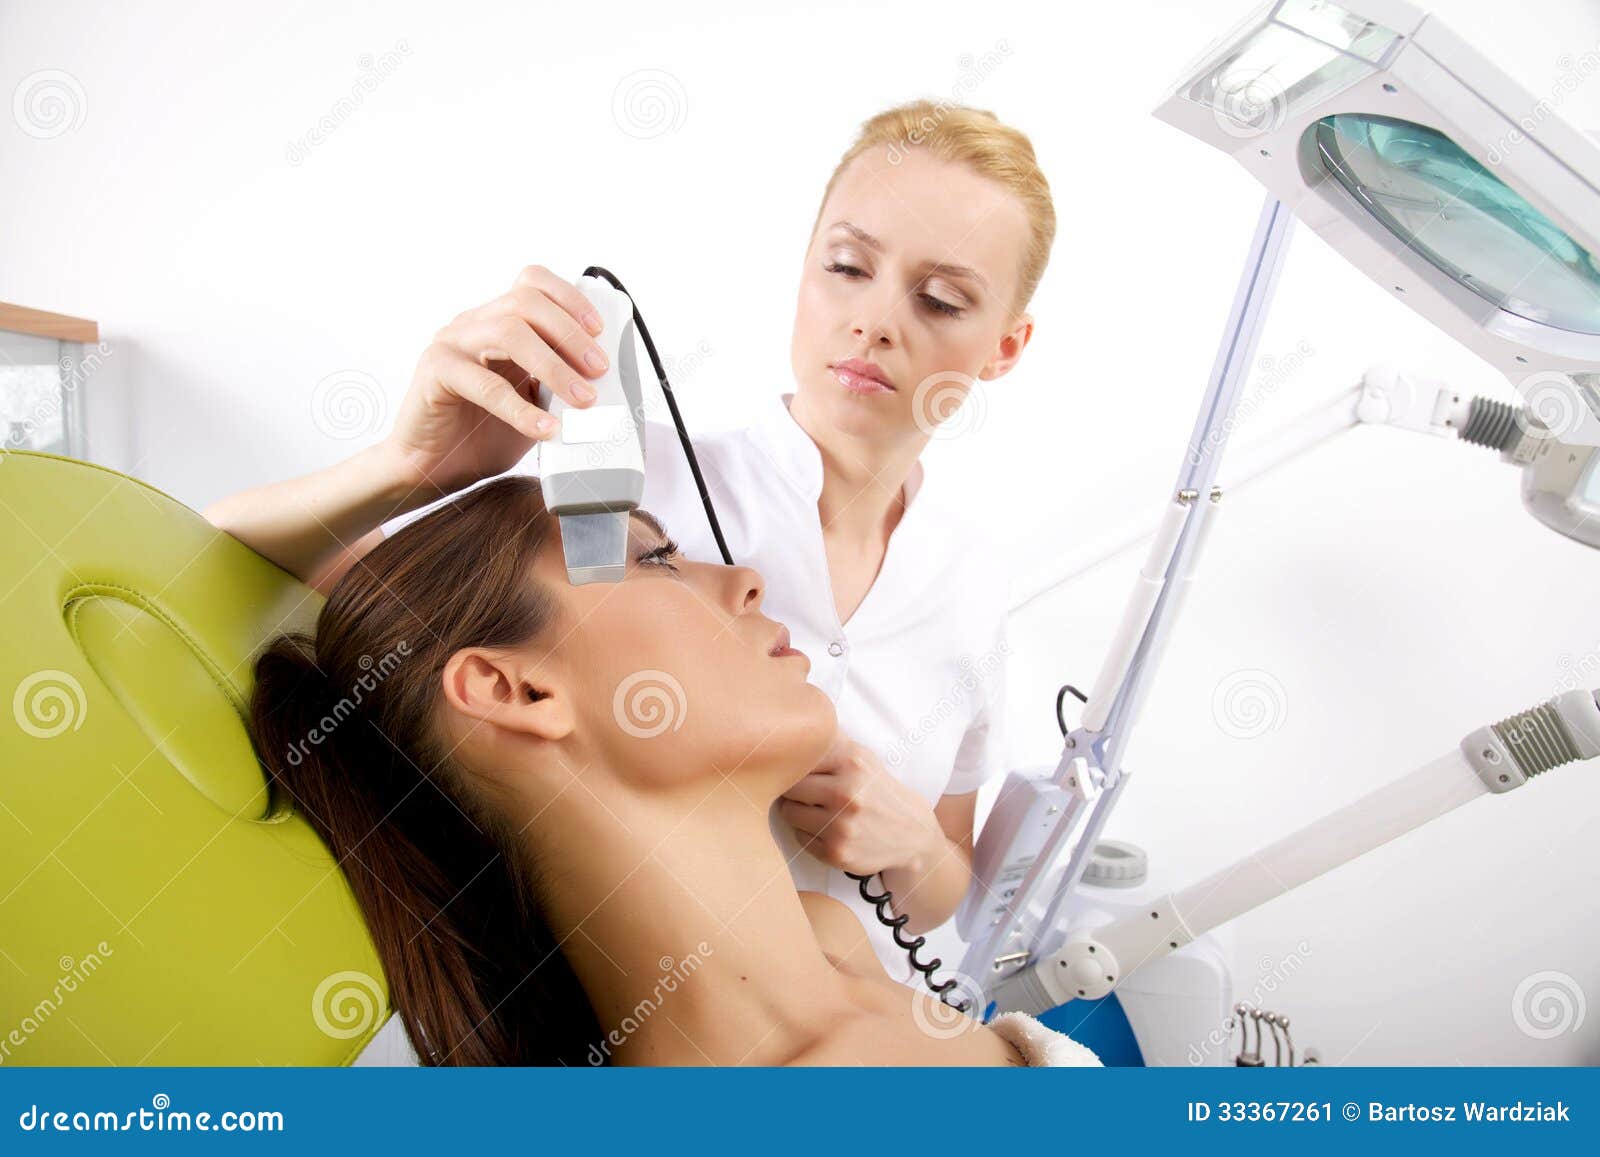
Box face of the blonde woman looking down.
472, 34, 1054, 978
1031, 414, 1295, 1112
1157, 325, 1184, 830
789, 146, 1032, 438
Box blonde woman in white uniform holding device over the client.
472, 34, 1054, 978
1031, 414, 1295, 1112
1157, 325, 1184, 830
206, 101, 1056, 983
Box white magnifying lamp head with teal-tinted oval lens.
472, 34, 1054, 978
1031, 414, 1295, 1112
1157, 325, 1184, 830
1155, 0, 1600, 546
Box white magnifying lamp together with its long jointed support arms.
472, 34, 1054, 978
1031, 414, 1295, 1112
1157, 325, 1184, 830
957, 0, 1600, 1049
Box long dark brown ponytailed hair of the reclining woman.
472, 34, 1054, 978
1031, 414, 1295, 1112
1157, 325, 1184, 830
250, 475, 600, 1064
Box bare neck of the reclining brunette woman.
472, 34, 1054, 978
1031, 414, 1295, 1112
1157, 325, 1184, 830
530, 776, 848, 1066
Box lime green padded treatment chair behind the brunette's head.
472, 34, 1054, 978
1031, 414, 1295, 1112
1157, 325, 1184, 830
0, 451, 390, 1066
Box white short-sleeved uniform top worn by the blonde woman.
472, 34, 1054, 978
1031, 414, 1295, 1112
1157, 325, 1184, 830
384, 394, 1010, 983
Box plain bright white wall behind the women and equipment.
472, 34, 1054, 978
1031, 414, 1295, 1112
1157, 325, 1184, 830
0, 0, 1600, 1064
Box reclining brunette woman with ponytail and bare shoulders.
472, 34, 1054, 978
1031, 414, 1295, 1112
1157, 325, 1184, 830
251, 475, 1099, 1066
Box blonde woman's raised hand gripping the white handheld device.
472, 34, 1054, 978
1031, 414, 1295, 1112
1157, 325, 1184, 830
382, 266, 608, 496
